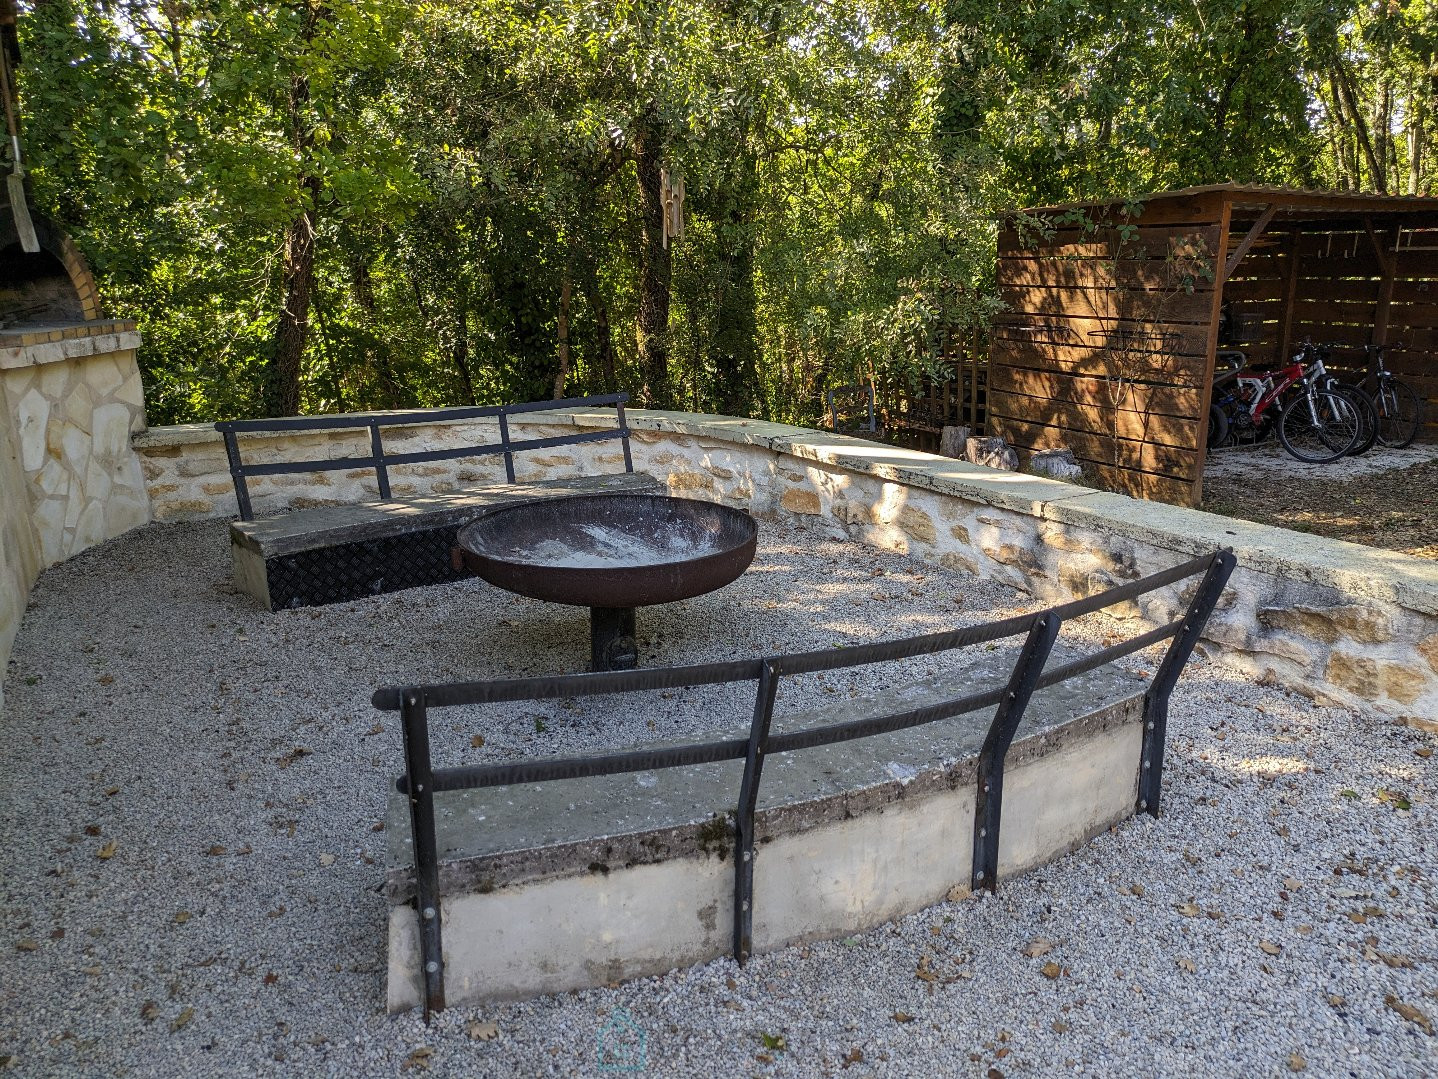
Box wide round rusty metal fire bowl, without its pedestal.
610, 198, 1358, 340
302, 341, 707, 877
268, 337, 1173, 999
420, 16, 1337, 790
459, 495, 759, 607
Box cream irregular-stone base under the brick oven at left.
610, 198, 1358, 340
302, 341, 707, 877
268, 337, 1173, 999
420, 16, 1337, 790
0, 322, 150, 719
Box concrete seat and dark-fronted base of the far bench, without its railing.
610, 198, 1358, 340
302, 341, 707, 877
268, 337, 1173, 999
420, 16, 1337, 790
230, 472, 663, 610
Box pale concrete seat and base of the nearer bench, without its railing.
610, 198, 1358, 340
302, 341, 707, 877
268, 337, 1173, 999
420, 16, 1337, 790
387, 656, 1145, 1011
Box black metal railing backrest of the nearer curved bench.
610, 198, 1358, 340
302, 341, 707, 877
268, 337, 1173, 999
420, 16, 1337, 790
374, 550, 1234, 1019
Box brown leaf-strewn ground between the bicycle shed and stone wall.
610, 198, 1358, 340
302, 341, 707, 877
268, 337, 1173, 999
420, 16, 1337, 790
1204, 447, 1438, 558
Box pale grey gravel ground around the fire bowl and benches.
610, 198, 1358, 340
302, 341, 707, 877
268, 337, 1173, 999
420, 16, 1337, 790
0, 522, 1438, 1076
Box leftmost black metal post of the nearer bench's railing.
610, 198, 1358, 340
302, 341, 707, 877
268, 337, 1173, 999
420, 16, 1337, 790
400, 689, 444, 1023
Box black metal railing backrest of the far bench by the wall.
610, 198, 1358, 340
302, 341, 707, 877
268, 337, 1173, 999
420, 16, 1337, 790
214, 393, 634, 521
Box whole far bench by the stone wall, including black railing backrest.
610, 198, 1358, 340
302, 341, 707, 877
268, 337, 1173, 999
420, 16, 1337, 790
214, 394, 649, 610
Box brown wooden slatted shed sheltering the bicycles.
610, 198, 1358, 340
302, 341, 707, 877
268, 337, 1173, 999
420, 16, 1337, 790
988, 184, 1438, 505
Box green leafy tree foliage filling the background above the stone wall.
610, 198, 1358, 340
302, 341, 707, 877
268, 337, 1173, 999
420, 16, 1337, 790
8, 0, 1438, 423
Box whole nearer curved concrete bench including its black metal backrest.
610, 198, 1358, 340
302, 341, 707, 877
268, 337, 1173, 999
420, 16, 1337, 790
374, 551, 1234, 1014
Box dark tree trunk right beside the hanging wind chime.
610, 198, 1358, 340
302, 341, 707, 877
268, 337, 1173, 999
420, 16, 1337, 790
634, 118, 674, 409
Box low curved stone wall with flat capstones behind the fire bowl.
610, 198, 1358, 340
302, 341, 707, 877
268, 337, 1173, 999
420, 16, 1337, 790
137, 410, 1438, 719
